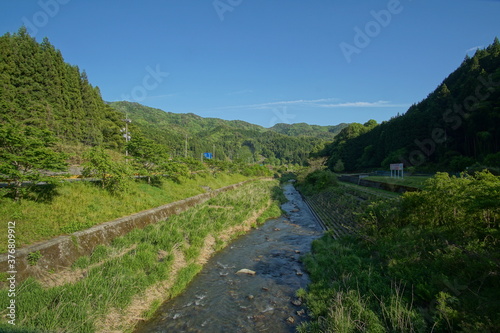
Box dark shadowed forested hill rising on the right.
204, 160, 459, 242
323, 38, 500, 172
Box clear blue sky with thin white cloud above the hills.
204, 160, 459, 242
0, 0, 500, 127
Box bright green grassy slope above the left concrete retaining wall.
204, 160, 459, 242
0, 173, 249, 248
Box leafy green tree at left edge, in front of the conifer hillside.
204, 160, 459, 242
0, 122, 67, 201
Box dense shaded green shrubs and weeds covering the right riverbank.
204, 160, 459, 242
298, 172, 500, 332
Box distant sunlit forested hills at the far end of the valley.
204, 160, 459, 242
109, 102, 335, 164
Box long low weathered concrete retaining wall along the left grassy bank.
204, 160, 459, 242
0, 180, 253, 285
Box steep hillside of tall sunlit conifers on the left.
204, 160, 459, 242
0, 27, 124, 149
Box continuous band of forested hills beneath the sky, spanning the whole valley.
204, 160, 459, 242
0, 27, 500, 171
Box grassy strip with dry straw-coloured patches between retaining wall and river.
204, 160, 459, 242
0, 180, 284, 333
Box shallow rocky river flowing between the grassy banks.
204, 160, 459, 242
135, 184, 323, 333
